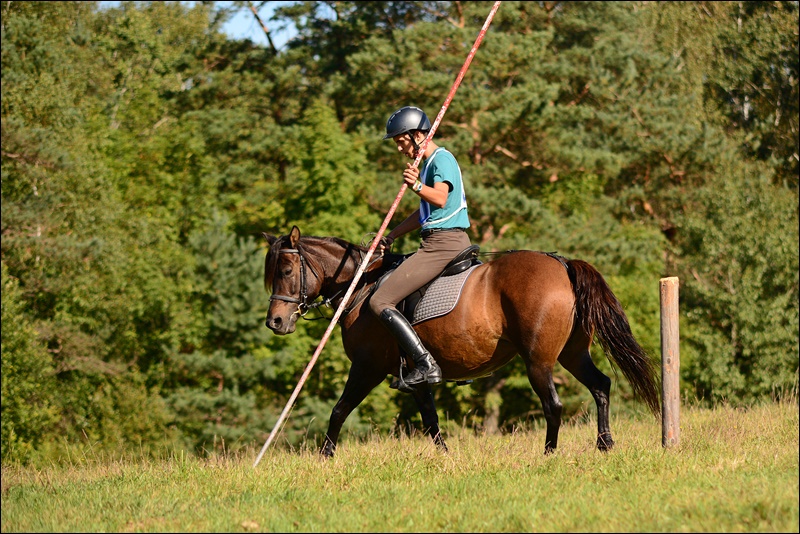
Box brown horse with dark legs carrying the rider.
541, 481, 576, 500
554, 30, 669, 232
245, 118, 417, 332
264, 226, 660, 457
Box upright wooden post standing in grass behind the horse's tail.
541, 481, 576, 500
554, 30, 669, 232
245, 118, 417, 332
659, 276, 681, 447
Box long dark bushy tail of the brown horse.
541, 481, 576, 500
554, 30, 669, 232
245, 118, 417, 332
567, 260, 661, 415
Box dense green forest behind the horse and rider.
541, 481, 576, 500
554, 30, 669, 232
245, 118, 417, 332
0, 1, 800, 462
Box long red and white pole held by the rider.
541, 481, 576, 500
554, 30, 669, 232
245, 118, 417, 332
253, 1, 501, 467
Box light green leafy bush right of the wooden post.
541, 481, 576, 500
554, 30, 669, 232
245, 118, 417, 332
678, 165, 800, 400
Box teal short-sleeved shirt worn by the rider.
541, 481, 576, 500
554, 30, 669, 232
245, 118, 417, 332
419, 147, 469, 230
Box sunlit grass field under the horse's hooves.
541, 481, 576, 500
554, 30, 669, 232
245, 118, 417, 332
2, 401, 800, 532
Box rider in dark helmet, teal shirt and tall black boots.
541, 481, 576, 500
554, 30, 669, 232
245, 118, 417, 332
369, 106, 470, 385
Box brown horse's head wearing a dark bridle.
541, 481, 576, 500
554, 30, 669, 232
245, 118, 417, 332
264, 226, 322, 336
